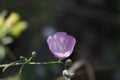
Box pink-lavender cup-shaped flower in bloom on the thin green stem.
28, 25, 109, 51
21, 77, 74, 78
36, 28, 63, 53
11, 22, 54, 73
47, 32, 76, 59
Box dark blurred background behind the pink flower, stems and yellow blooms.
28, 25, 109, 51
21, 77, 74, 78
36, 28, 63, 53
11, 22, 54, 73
0, 0, 120, 80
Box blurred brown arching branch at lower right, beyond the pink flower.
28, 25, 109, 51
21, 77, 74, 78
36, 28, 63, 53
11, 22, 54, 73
55, 60, 120, 80
